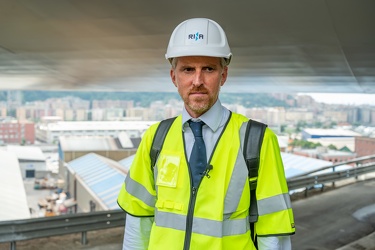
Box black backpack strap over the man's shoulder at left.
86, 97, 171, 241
150, 117, 176, 169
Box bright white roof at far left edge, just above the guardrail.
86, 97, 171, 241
0, 150, 30, 221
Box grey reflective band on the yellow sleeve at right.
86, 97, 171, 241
258, 194, 292, 215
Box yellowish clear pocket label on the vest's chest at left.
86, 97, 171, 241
156, 155, 180, 187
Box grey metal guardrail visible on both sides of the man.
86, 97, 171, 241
0, 155, 375, 250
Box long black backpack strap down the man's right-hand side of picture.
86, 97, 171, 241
243, 120, 267, 247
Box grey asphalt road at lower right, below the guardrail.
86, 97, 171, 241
292, 179, 375, 250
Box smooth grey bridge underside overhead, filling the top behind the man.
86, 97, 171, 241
0, 0, 375, 93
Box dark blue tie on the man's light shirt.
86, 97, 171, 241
189, 121, 207, 187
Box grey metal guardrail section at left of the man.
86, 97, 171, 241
0, 210, 125, 250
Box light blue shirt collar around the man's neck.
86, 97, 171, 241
182, 99, 225, 132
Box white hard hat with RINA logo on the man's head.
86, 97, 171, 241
165, 18, 232, 64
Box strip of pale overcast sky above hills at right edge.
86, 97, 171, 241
301, 93, 375, 106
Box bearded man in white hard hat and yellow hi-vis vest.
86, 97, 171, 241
118, 18, 295, 250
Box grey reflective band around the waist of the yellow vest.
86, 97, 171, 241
155, 211, 249, 238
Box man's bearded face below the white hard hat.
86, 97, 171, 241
170, 56, 228, 118
